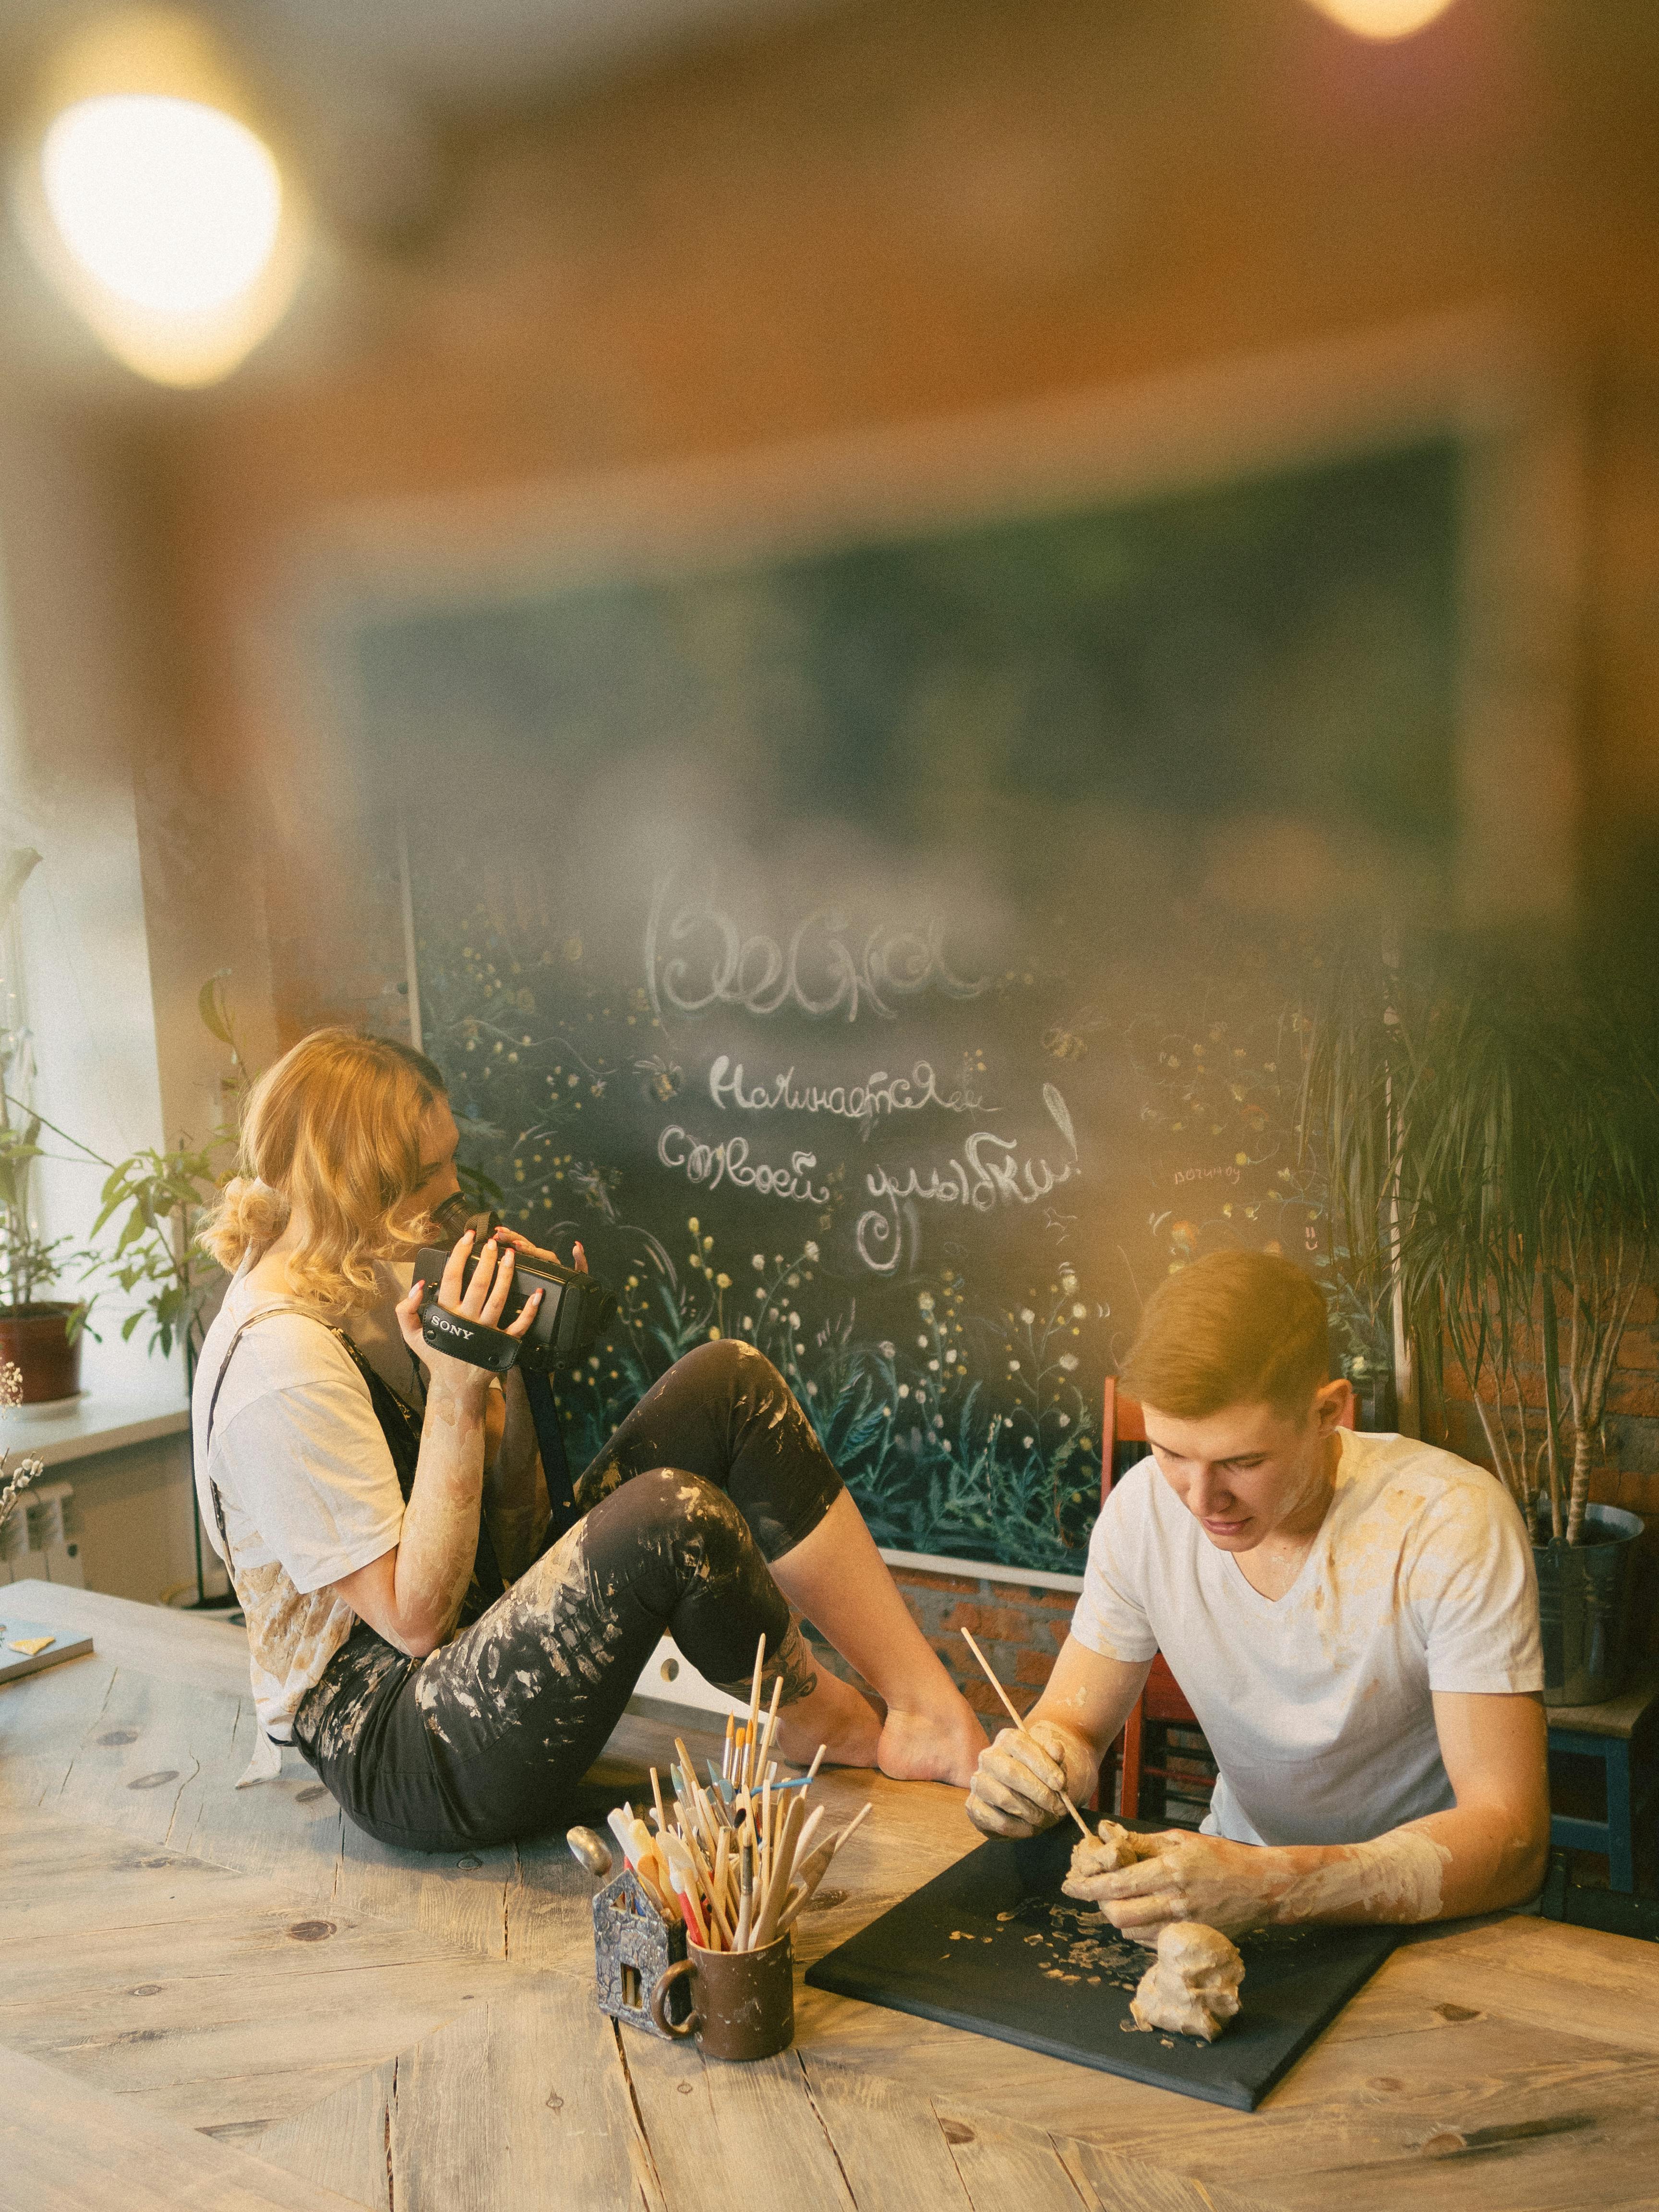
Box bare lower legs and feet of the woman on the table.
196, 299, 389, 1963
772, 1491, 985, 1790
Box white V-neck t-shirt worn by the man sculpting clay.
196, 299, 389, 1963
1070, 1431, 1544, 1842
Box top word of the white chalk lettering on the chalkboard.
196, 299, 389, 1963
646, 876, 991, 1022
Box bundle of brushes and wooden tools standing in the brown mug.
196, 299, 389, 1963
611, 1637, 869, 1951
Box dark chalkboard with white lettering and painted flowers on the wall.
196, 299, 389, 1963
349, 443, 1458, 1573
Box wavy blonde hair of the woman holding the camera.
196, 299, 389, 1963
201, 1029, 445, 1312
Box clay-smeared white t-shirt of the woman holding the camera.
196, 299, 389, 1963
192, 1267, 421, 1743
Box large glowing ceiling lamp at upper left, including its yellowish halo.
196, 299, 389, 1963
15, 9, 308, 385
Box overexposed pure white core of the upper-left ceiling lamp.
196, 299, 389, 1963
40, 93, 283, 316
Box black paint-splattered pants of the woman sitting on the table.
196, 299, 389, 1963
294, 1343, 843, 1851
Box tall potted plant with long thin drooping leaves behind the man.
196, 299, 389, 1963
1296, 938, 1659, 1706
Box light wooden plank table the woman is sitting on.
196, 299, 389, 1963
0, 1584, 1659, 2212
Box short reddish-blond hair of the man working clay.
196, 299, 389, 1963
1119, 1252, 1332, 1420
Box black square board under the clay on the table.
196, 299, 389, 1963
807, 1823, 1398, 2113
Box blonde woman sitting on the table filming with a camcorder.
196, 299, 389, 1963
195, 1029, 985, 1851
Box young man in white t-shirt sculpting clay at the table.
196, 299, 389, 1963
969, 1252, 1549, 1944
